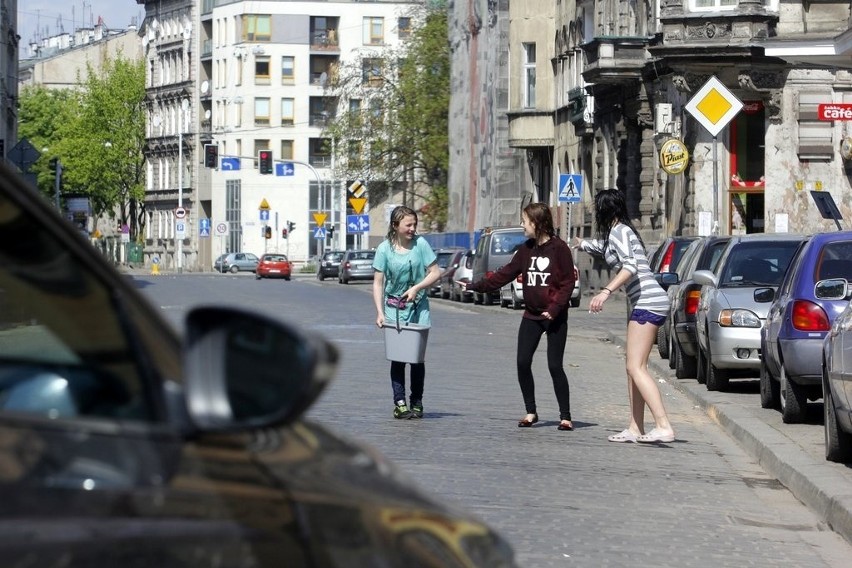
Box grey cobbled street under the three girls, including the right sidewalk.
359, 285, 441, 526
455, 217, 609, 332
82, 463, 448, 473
134, 274, 852, 567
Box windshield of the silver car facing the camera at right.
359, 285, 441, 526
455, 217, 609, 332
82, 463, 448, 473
719, 240, 799, 287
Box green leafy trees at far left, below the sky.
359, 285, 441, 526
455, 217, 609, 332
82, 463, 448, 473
19, 56, 145, 235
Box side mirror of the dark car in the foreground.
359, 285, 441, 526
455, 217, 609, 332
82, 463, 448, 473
184, 307, 339, 431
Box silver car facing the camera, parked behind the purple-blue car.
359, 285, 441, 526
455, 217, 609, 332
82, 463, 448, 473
693, 233, 805, 390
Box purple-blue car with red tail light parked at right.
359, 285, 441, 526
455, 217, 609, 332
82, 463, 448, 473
760, 231, 852, 423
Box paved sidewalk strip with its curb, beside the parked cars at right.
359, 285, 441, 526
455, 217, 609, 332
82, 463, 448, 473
596, 298, 852, 543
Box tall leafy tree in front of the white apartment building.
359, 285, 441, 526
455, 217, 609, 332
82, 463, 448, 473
325, 3, 450, 230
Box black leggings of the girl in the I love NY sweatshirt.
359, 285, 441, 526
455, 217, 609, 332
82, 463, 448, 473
518, 313, 571, 420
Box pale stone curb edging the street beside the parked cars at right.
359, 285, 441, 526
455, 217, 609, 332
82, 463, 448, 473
608, 332, 852, 544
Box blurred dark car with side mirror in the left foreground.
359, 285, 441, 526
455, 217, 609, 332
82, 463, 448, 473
0, 166, 515, 568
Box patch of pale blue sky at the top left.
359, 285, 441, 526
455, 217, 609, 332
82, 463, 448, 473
18, 0, 145, 47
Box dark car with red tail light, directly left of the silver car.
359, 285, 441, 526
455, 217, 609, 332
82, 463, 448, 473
662, 236, 730, 379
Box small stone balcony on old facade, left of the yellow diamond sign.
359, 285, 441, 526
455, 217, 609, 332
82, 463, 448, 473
582, 37, 650, 85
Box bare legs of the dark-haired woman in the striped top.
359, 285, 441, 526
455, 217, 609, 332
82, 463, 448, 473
627, 321, 674, 432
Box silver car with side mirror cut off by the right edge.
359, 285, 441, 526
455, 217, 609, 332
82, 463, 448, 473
816, 288, 852, 463
